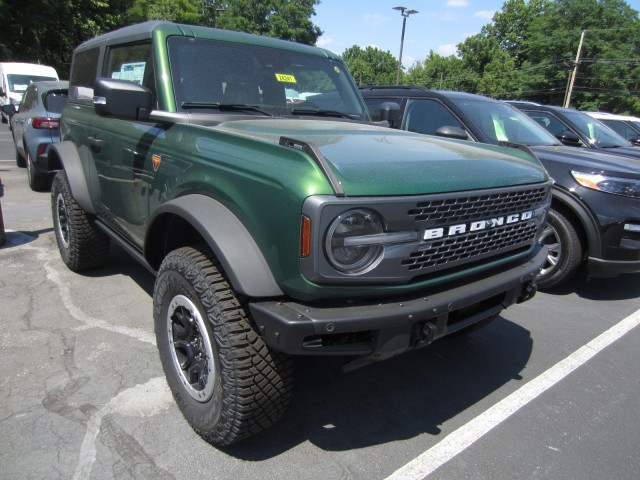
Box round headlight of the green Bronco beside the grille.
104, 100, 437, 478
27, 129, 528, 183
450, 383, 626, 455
325, 209, 384, 275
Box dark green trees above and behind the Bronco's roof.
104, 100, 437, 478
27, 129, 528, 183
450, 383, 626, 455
0, 0, 322, 78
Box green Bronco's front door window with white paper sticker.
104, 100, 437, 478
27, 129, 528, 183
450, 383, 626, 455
104, 43, 156, 103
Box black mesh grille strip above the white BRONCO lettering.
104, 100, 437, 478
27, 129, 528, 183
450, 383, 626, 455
408, 188, 546, 226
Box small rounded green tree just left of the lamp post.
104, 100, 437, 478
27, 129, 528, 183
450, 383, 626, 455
342, 45, 398, 86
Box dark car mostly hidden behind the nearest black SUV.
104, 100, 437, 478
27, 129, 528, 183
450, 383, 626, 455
507, 101, 640, 158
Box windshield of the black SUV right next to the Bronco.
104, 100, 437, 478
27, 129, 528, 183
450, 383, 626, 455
444, 98, 559, 146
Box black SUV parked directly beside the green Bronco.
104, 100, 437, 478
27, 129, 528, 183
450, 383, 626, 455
361, 86, 640, 288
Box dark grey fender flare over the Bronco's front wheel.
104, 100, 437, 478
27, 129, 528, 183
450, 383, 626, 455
145, 194, 283, 297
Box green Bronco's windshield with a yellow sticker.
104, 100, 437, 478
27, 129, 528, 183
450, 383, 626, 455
168, 37, 368, 120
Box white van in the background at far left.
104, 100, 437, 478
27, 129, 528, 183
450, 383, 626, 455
0, 62, 59, 123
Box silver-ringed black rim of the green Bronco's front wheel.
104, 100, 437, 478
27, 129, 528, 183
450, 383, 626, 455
167, 295, 215, 402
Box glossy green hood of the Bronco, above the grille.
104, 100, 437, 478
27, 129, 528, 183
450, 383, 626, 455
215, 119, 548, 196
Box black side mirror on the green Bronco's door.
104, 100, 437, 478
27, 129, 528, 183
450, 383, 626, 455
93, 78, 153, 120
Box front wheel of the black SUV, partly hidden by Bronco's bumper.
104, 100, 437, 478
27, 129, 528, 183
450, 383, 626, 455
536, 210, 583, 290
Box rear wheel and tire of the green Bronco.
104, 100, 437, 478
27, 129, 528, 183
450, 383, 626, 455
51, 171, 110, 272
